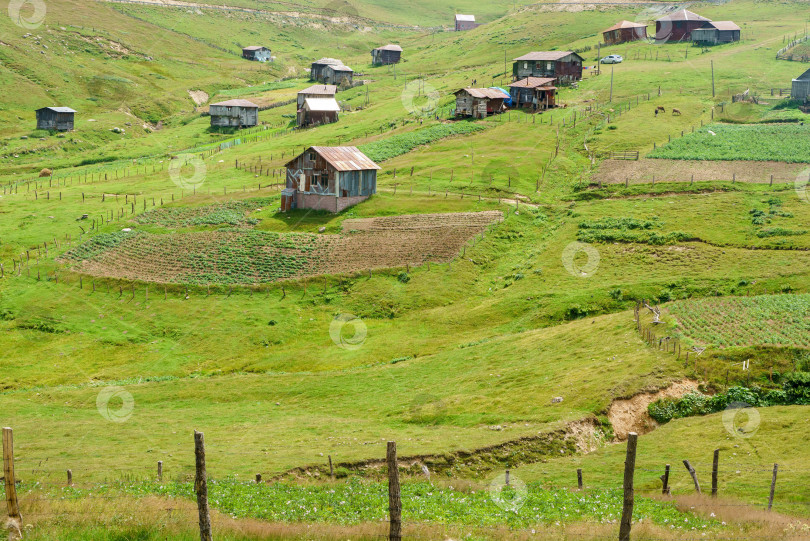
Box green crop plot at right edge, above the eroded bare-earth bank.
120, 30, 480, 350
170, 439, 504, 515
667, 294, 810, 348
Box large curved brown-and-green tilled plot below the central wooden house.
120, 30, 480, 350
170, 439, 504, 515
62, 210, 503, 285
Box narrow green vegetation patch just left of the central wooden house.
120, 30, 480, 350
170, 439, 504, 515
131, 197, 274, 227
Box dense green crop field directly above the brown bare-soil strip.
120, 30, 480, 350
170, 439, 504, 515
647, 124, 810, 163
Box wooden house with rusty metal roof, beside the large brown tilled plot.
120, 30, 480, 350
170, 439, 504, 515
281, 147, 380, 212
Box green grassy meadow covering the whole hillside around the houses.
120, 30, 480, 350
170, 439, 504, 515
0, 0, 810, 541
